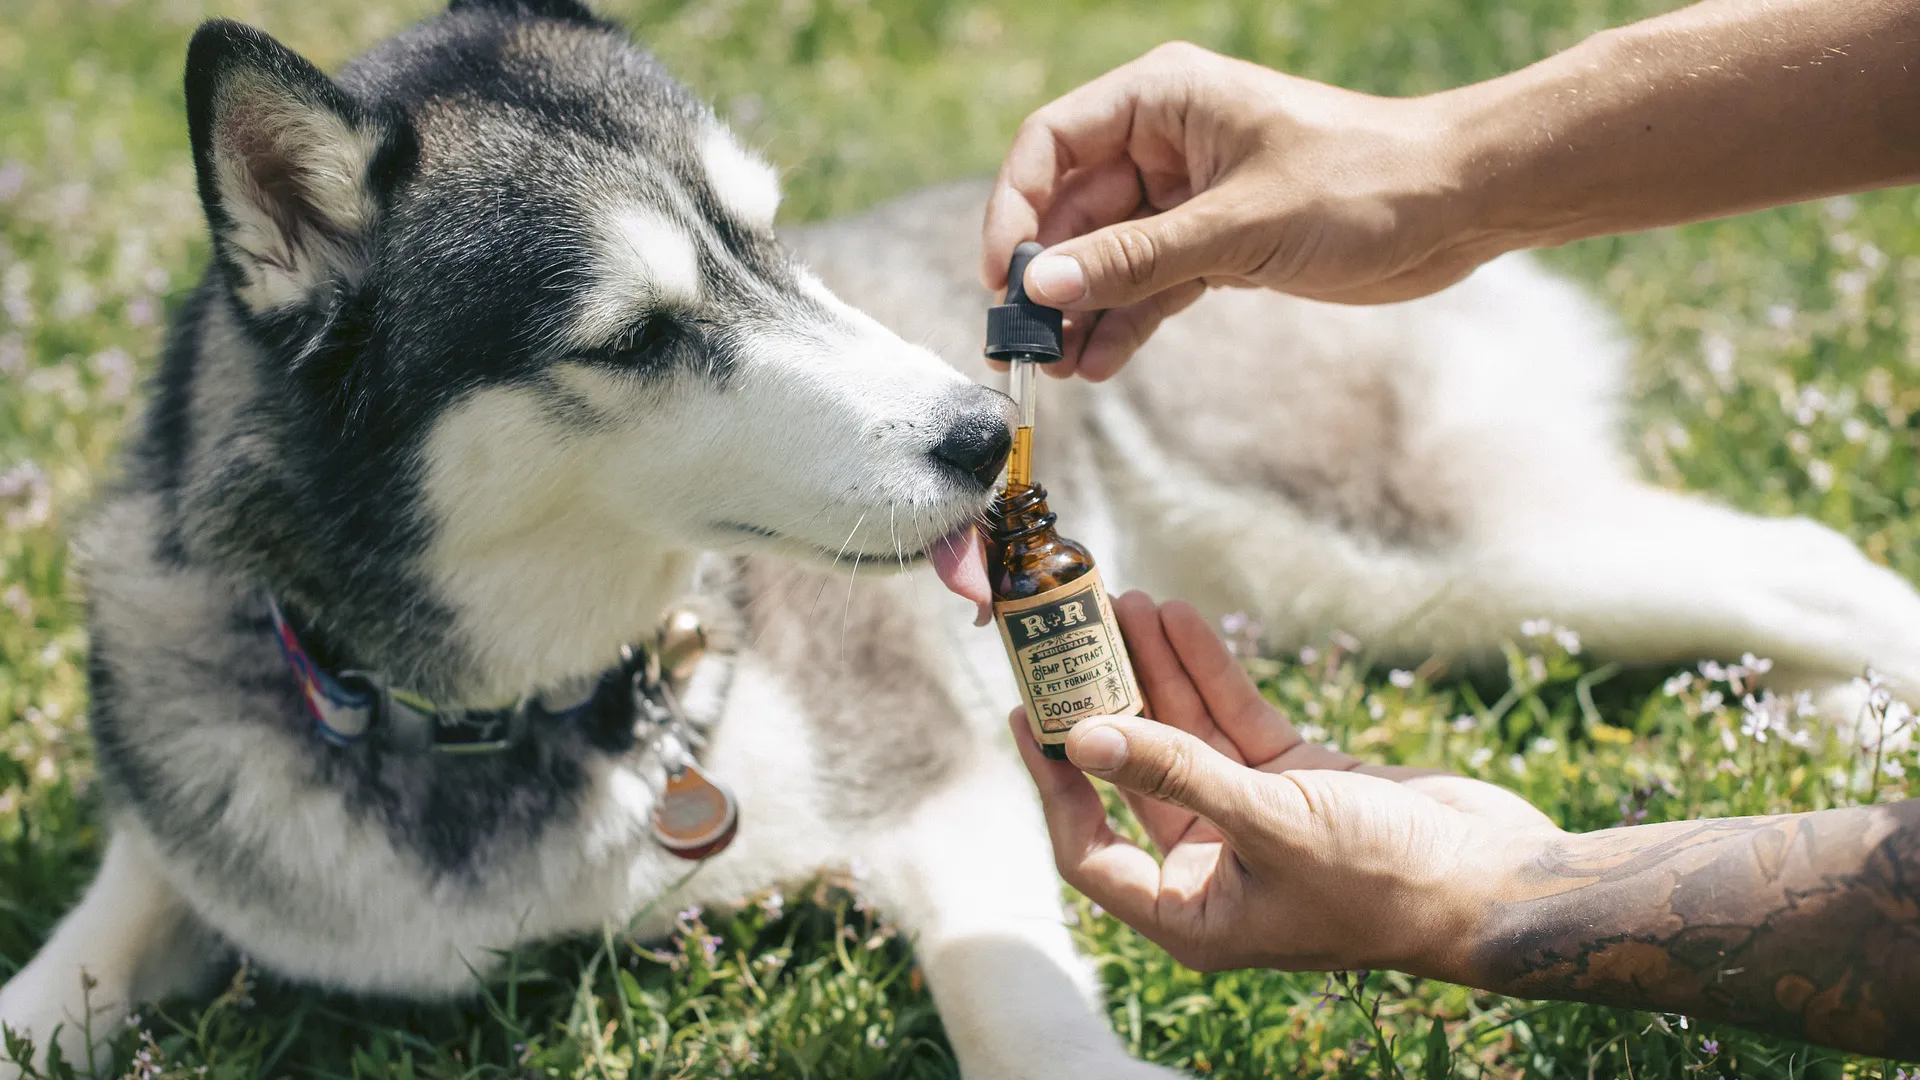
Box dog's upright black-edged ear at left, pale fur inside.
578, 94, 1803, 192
186, 19, 415, 313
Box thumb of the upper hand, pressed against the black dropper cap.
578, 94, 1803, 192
1027, 198, 1235, 311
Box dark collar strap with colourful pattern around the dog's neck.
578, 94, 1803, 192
267, 596, 610, 753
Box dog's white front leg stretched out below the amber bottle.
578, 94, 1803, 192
864, 748, 1173, 1080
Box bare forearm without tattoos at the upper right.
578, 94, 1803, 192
1436, 0, 1920, 250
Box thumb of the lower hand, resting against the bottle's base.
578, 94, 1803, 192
1068, 717, 1261, 832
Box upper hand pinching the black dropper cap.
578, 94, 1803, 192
981, 44, 1496, 380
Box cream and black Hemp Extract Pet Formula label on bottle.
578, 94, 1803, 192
993, 569, 1144, 744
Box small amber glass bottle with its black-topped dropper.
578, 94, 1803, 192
987, 244, 1144, 759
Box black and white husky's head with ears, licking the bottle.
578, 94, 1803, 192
186, 0, 1010, 687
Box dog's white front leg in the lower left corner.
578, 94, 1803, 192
0, 822, 213, 1080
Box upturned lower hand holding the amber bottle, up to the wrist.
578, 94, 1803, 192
1012, 592, 1561, 982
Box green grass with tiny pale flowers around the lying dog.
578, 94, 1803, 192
0, 0, 1920, 1080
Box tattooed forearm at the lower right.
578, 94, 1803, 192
1475, 799, 1920, 1057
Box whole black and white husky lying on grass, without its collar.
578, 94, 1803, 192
0, 0, 1920, 1080
